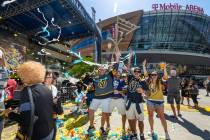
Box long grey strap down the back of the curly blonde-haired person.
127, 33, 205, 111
16, 87, 35, 140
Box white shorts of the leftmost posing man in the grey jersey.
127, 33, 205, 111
90, 98, 110, 113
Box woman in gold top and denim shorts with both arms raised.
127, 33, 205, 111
143, 60, 170, 140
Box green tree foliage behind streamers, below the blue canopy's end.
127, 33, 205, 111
69, 57, 94, 78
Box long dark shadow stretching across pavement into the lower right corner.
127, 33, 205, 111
165, 114, 210, 140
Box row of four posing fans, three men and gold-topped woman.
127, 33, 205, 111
83, 60, 171, 140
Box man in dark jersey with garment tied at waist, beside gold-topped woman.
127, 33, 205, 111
126, 68, 148, 140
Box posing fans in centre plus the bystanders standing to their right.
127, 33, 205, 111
78, 60, 209, 140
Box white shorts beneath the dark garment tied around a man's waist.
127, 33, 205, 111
126, 103, 144, 121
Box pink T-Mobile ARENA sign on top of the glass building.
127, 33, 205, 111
152, 3, 204, 14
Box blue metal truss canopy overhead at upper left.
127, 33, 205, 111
0, 0, 101, 59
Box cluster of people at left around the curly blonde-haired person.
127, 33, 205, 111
0, 50, 63, 140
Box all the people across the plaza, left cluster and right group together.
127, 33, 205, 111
0, 48, 210, 140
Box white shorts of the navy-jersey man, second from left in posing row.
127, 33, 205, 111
110, 98, 126, 115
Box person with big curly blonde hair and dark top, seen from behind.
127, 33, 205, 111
5, 61, 55, 140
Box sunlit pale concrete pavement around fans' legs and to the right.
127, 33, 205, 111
84, 89, 210, 140
